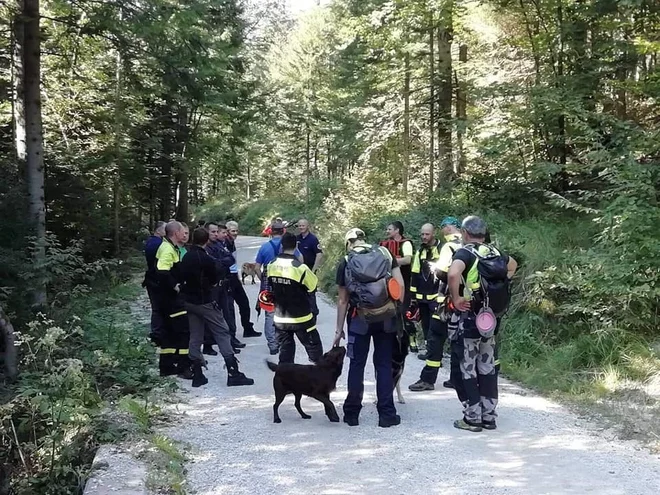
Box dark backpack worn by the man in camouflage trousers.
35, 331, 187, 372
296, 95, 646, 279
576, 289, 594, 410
464, 244, 511, 318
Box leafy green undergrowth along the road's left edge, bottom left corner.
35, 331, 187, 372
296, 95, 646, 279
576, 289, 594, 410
0, 262, 179, 495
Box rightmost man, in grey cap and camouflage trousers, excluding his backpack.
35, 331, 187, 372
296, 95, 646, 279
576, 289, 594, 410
447, 216, 518, 432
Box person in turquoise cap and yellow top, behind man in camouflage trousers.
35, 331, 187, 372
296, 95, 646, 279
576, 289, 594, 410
408, 217, 461, 392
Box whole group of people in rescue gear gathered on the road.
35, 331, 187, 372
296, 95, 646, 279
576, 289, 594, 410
145, 216, 517, 432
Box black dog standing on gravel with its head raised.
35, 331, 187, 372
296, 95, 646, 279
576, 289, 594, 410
266, 347, 346, 423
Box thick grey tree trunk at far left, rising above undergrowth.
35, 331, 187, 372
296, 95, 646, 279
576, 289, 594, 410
23, 0, 46, 306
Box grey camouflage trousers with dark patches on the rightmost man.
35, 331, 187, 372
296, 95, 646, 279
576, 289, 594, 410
455, 318, 497, 423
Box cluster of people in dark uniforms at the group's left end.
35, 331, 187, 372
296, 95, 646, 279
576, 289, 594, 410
143, 220, 261, 387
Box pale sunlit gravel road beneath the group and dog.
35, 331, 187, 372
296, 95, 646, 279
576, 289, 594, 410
165, 237, 660, 495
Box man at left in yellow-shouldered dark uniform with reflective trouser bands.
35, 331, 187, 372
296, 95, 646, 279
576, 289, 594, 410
156, 221, 192, 379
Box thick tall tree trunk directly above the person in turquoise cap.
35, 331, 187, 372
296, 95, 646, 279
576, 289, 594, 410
438, 0, 454, 184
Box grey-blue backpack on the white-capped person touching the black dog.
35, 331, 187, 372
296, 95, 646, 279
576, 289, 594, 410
345, 245, 396, 323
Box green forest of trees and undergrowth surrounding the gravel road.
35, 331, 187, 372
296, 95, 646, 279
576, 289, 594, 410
0, 0, 660, 494
